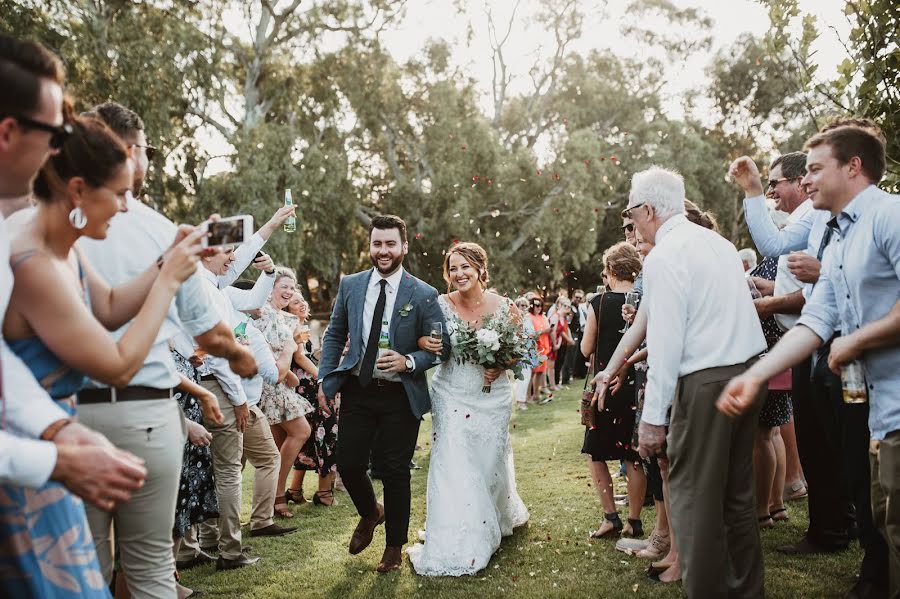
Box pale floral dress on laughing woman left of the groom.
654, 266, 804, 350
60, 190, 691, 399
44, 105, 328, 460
255, 304, 315, 425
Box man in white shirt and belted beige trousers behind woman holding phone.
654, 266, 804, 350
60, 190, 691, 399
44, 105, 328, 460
78, 103, 256, 599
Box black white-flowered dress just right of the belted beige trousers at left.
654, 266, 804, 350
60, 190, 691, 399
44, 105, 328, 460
172, 350, 219, 537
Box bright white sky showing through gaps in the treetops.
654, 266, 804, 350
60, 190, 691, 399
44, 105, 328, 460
201, 0, 849, 175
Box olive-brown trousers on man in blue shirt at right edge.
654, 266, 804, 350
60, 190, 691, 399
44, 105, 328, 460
869, 431, 900, 599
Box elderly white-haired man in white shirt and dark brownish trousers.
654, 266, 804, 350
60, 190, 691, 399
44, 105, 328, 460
626, 167, 766, 599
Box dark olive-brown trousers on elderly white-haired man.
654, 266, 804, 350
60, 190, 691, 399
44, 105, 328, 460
667, 362, 766, 599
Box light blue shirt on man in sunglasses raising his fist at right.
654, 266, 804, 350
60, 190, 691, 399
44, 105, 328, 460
744, 195, 831, 301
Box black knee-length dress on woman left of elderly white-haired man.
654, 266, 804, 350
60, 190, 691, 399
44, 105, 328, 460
581, 292, 640, 462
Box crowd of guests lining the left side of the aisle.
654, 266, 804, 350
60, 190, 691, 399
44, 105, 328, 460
0, 35, 337, 597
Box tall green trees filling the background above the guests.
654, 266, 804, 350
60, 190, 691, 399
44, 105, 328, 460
0, 0, 900, 309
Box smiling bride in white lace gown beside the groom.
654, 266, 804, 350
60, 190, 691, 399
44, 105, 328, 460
407, 243, 528, 576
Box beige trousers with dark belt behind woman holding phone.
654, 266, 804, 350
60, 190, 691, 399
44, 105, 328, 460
78, 397, 187, 599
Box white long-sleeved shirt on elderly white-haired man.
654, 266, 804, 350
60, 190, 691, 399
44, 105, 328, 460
642, 214, 766, 425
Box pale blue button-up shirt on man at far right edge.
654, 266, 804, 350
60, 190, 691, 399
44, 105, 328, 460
797, 185, 900, 440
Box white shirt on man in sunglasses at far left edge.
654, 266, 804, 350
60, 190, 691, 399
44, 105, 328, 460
0, 214, 69, 488
